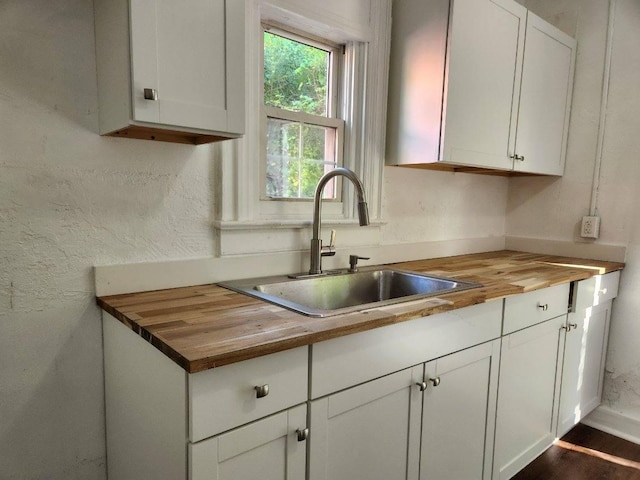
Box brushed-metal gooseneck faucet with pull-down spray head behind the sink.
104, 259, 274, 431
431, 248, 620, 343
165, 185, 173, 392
309, 167, 369, 275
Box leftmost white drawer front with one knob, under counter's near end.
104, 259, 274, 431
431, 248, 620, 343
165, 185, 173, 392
189, 347, 308, 442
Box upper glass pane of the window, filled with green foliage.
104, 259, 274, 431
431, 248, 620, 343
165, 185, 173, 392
264, 32, 331, 117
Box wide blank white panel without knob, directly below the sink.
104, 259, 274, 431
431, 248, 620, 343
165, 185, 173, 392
311, 301, 502, 398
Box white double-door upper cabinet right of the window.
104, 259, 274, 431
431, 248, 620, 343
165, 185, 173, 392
387, 0, 575, 175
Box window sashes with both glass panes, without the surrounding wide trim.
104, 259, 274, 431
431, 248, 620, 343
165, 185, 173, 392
262, 26, 344, 200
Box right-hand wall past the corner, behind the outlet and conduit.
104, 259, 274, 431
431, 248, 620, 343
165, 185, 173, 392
506, 0, 640, 428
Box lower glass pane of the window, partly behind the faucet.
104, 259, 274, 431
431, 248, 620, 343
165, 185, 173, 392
265, 118, 337, 199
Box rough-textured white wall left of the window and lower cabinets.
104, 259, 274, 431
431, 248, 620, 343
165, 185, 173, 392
0, 0, 214, 480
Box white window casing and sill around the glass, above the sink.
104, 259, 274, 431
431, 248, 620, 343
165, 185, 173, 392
212, 0, 391, 251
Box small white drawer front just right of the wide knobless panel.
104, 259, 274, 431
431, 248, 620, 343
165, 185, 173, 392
502, 283, 569, 335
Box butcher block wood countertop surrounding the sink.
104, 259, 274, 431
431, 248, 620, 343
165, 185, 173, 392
97, 250, 624, 373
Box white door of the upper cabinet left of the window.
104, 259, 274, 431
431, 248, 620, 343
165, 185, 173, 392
130, 0, 244, 133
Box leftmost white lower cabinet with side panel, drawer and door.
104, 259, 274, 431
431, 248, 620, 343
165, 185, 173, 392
103, 313, 308, 480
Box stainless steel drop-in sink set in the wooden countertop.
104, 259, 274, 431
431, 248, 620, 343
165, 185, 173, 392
220, 268, 480, 317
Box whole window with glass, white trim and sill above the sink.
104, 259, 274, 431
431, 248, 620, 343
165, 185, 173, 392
212, 0, 391, 256
